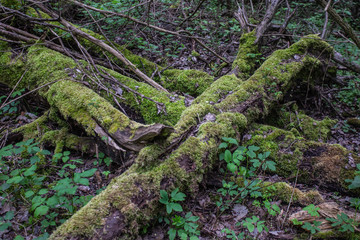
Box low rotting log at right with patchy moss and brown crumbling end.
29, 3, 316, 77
246, 123, 360, 194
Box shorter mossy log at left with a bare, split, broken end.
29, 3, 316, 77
0, 46, 172, 151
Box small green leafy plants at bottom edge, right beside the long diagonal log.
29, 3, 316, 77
159, 188, 200, 240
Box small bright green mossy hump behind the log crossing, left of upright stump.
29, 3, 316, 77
160, 69, 214, 96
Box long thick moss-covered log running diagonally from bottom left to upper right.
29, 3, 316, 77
35, 35, 332, 239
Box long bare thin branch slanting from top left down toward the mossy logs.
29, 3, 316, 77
31, 1, 168, 92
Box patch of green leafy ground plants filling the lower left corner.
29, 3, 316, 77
0, 139, 109, 240
